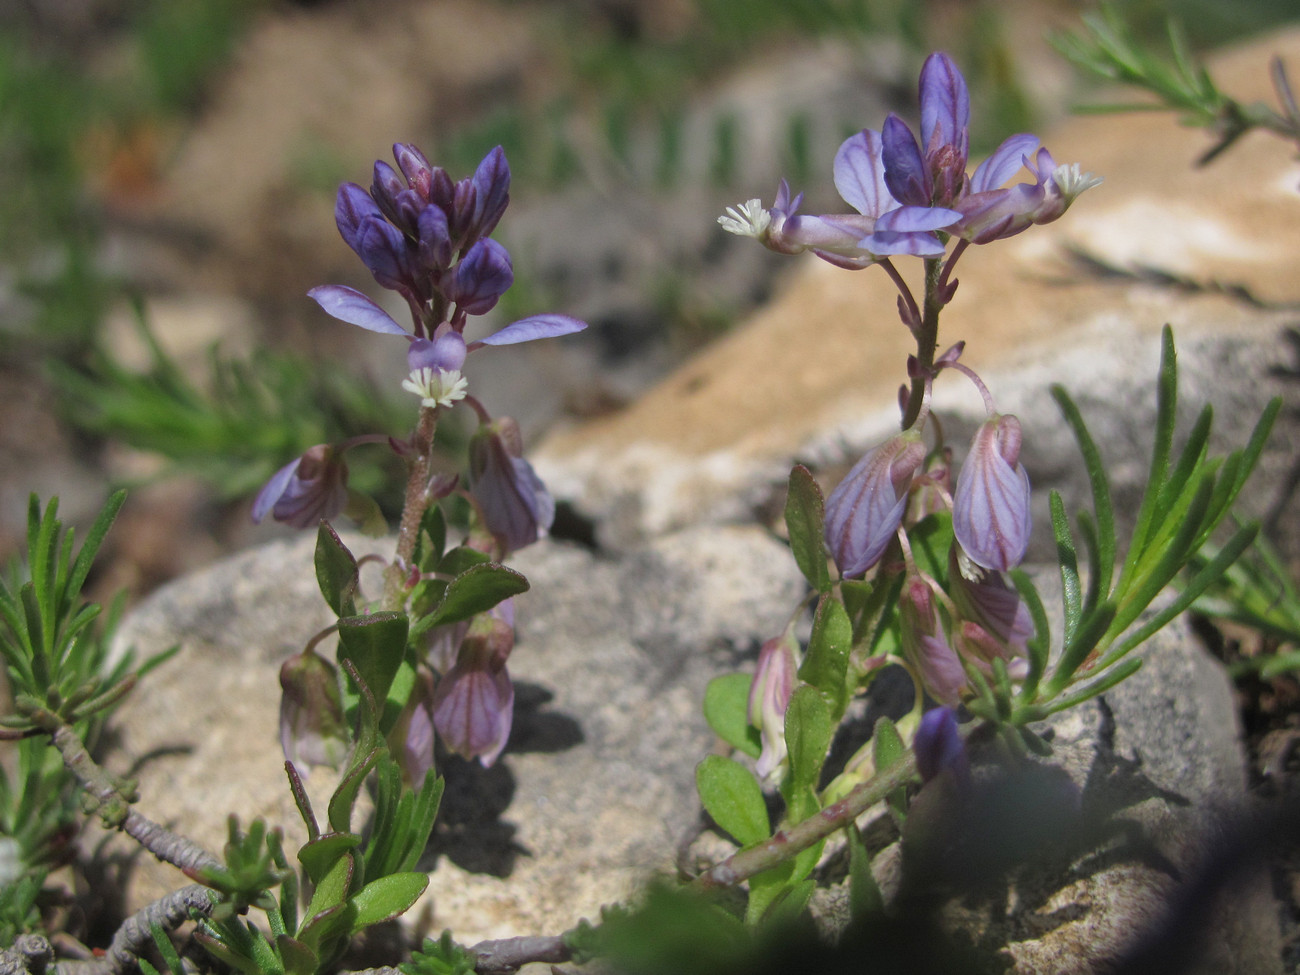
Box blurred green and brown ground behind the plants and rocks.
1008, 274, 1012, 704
0, 0, 1296, 595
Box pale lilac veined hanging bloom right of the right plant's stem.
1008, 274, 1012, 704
953, 413, 1031, 572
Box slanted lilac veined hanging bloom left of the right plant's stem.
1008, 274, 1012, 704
826, 430, 926, 577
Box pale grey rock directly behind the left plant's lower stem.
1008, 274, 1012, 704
113, 527, 802, 943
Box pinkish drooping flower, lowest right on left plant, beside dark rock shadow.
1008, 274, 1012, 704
433, 614, 515, 768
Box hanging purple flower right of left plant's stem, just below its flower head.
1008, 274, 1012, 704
468, 416, 555, 558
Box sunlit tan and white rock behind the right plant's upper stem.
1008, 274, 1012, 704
537, 31, 1300, 556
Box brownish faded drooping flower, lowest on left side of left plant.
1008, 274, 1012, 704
280, 650, 348, 774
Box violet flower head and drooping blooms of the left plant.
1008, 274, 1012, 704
261, 143, 586, 781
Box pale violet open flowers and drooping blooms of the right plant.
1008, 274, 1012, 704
719, 53, 1100, 777
